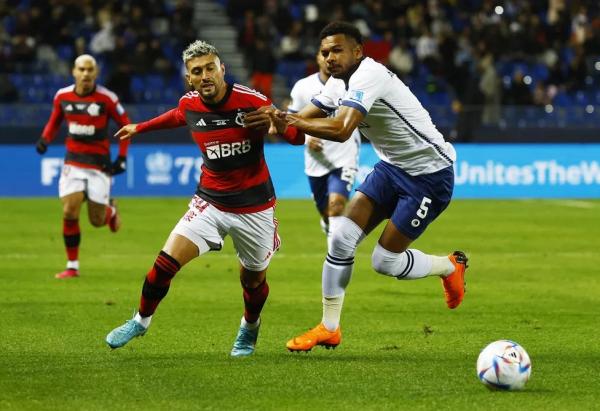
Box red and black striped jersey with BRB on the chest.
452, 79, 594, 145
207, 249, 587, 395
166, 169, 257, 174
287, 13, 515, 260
136, 84, 304, 213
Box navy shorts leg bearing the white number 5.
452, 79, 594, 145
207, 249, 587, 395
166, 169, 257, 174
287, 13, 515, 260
382, 167, 454, 245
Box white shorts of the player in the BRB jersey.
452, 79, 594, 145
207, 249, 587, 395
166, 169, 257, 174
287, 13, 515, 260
172, 195, 281, 271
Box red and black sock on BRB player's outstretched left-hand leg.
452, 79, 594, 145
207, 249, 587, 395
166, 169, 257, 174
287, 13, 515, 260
138, 251, 181, 317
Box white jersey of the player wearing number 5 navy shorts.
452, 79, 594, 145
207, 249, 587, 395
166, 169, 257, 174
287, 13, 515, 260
312, 57, 456, 176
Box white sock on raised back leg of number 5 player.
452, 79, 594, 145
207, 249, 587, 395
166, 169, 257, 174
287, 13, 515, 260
371, 244, 454, 280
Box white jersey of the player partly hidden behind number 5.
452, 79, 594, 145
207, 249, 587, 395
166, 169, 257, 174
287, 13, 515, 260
288, 73, 360, 177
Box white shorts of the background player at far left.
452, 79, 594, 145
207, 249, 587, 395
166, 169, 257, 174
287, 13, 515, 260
58, 164, 110, 204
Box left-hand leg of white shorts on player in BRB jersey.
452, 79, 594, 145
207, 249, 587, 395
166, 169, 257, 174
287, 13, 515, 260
171, 196, 227, 261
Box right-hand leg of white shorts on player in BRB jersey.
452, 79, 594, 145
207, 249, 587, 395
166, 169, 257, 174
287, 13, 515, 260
229, 208, 281, 271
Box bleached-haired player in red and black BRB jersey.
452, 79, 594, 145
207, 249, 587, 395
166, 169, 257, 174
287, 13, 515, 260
106, 41, 304, 357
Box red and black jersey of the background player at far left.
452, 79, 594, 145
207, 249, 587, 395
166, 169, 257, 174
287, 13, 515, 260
42, 85, 130, 170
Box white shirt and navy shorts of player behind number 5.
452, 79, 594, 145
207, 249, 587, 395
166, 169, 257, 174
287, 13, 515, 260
288, 73, 360, 212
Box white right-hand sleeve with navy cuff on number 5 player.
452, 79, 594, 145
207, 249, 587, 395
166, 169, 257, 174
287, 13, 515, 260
341, 63, 388, 116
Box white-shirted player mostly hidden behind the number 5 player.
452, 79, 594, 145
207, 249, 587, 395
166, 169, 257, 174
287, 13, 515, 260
288, 53, 360, 245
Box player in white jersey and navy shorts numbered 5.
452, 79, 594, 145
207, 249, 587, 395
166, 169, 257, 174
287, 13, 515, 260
253, 22, 467, 351
